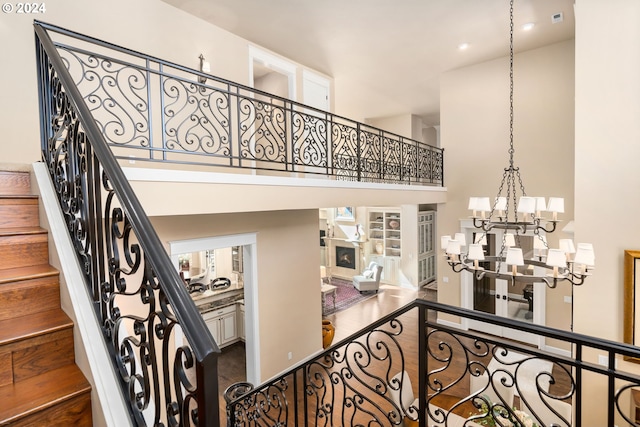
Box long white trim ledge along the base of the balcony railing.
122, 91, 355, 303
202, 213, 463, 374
122, 167, 447, 192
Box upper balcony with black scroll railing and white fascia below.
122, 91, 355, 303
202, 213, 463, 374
42, 20, 446, 216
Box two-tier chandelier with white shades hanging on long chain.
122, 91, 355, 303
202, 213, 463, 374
441, 0, 595, 288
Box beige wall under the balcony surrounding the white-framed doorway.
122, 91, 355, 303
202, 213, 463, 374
151, 209, 322, 381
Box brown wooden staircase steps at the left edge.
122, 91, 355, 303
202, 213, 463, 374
0, 171, 92, 427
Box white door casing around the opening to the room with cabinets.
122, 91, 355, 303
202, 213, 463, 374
169, 233, 262, 384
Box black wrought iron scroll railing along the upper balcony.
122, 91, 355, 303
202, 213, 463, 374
31, 24, 444, 186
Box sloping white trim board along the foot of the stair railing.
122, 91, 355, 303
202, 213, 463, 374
33, 162, 132, 427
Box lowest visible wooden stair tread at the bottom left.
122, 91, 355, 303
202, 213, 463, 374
0, 365, 91, 425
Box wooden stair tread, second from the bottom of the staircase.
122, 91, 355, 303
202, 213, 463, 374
0, 308, 73, 348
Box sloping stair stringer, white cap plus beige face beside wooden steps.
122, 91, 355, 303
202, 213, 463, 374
32, 162, 134, 427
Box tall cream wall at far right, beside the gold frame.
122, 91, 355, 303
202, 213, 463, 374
574, 0, 640, 426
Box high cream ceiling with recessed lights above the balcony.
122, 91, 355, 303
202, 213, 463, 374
163, 0, 575, 124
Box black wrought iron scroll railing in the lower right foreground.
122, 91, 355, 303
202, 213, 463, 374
227, 300, 640, 427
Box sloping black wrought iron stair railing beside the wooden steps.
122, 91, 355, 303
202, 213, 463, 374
35, 22, 219, 426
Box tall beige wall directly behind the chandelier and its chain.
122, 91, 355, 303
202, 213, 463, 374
437, 41, 574, 336
